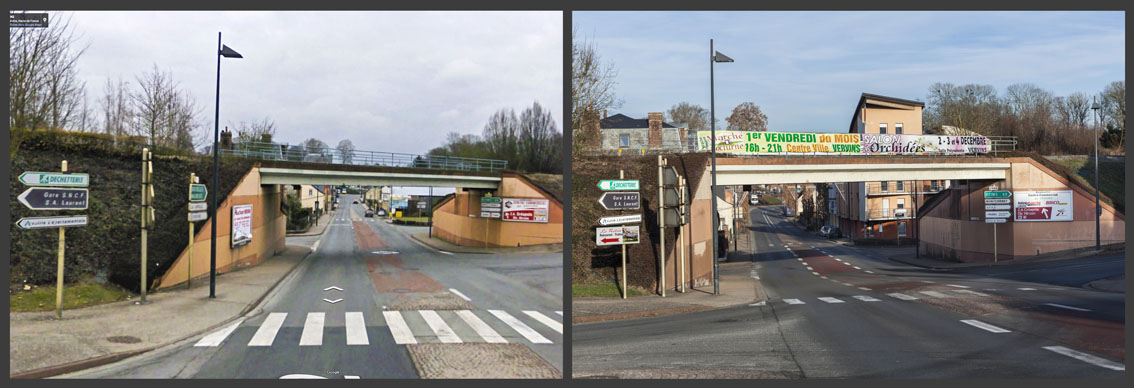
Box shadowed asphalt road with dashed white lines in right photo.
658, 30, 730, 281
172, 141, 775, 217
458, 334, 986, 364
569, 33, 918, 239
573, 208, 1125, 379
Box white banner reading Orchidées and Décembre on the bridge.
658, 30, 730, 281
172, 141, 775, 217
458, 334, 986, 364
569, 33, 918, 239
862, 134, 989, 154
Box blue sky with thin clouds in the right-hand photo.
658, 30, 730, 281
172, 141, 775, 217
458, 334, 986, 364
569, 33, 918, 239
572, 11, 1126, 132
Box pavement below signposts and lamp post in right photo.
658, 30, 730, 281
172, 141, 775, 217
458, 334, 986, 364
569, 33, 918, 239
572, 262, 764, 323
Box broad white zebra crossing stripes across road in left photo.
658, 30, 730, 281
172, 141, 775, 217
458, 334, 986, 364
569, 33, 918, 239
199, 310, 564, 347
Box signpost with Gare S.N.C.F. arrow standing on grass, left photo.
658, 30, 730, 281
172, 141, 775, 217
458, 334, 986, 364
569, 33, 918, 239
16, 160, 91, 319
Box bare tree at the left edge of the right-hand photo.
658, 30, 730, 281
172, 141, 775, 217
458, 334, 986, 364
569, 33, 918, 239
570, 27, 623, 149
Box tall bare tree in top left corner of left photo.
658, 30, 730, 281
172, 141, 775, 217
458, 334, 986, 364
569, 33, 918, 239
8, 13, 86, 129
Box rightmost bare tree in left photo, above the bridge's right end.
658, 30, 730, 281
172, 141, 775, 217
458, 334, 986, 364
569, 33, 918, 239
513, 102, 562, 172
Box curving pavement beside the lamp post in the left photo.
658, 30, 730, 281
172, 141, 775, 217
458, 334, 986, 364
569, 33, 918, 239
8, 245, 311, 378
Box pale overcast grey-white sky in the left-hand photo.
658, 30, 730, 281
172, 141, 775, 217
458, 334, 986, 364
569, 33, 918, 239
59, 11, 564, 153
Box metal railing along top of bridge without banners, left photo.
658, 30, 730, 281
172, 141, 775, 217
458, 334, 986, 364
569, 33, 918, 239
220, 142, 508, 172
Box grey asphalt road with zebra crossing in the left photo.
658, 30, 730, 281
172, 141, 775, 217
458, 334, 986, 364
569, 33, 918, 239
67, 195, 564, 379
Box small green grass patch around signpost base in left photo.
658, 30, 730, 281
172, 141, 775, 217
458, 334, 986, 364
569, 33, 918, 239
8, 282, 134, 312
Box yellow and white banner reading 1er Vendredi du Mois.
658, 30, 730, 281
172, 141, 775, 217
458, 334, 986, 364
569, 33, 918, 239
697, 130, 861, 154
